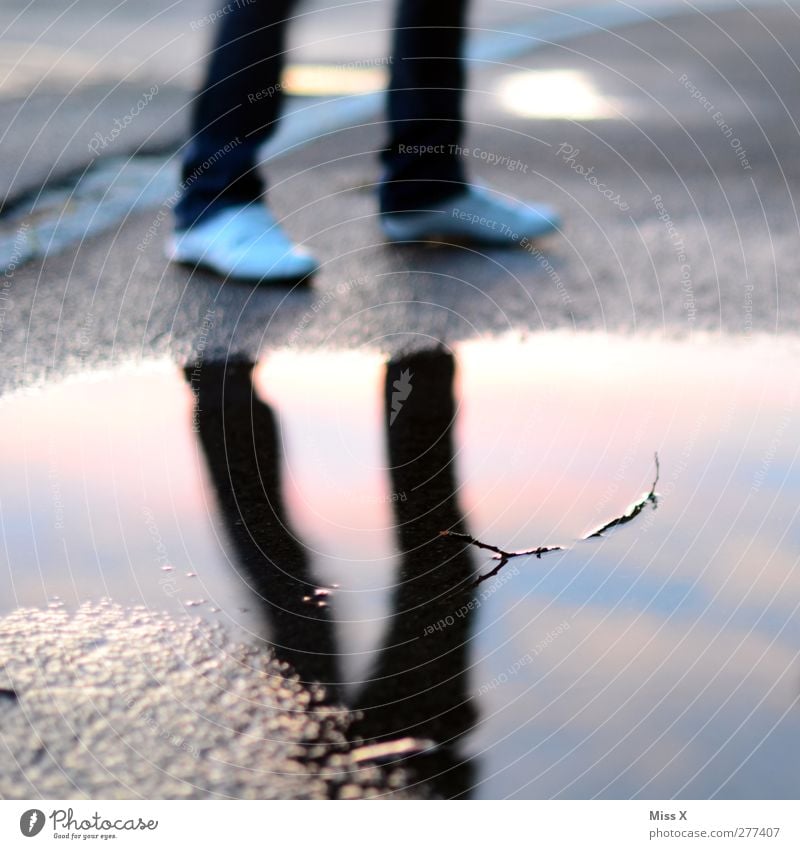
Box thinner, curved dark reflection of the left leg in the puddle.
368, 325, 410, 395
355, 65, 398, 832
186, 362, 338, 682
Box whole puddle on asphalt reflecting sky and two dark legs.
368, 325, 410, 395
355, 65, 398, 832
0, 334, 800, 798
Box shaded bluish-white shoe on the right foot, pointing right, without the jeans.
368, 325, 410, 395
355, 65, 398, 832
380, 186, 561, 245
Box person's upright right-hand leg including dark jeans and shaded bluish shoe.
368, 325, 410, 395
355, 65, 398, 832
380, 0, 559, 245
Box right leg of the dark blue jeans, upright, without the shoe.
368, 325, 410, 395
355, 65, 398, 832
380, 0, 467, 212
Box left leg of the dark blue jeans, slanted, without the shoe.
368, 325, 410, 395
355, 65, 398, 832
175, 0, 294, 229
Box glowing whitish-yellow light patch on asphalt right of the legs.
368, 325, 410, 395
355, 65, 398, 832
498, 70, 616, 121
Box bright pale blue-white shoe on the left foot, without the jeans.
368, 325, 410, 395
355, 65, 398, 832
166, 203, 318, 283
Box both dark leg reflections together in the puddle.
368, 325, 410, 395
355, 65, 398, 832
185, 350, 477, 797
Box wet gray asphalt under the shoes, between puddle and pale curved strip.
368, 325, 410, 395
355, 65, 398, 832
2, 7, 800, 398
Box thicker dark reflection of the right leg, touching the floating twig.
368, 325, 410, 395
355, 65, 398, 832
354, 351, 475, 796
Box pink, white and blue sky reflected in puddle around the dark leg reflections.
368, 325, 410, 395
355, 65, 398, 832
0, 334, 800, 797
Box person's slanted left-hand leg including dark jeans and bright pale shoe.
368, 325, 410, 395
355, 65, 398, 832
166, 0, 317, 283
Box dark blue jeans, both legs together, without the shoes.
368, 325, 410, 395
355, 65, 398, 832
175, 0, 467, 229
